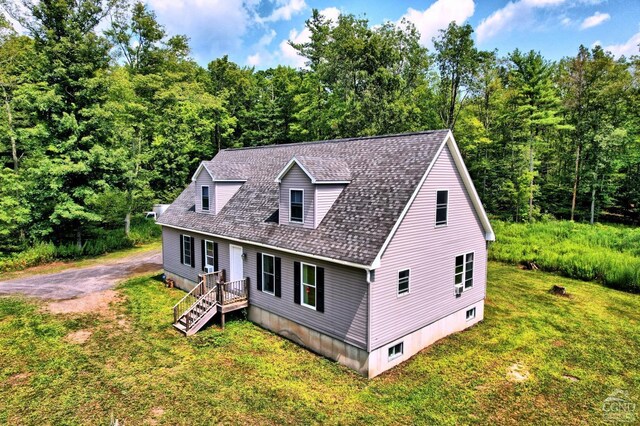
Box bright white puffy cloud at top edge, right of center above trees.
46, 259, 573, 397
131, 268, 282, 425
400, 0, 475, 47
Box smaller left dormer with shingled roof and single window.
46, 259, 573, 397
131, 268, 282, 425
191, 161, 246, 214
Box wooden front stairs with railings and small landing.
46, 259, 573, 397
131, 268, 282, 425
173, 270, 249, 336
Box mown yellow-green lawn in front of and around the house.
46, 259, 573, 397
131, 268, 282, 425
0, 263, 640, 425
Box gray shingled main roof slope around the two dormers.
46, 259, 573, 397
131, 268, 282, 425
158, 130, 448, 265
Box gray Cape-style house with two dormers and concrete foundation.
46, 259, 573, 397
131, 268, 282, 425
158, 130, 494, 377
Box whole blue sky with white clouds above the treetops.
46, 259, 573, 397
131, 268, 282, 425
147, 0, 640, 69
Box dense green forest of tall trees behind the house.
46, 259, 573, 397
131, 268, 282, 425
0, 0, 640, 255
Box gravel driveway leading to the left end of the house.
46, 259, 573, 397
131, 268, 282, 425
0, 250, 162, 300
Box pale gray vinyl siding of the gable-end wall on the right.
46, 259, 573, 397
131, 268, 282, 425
370, 146, 487, 350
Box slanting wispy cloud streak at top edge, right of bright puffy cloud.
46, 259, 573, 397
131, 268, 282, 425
476, 0, 566, 43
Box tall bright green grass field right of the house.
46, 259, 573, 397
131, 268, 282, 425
489, 221, 640, 292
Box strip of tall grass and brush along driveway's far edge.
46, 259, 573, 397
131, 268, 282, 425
0, 218, 162, 272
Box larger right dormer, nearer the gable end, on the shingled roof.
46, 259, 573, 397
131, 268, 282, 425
276, 156, 351, 229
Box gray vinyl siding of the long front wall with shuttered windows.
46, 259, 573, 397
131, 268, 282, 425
163, 227, 368, 349
